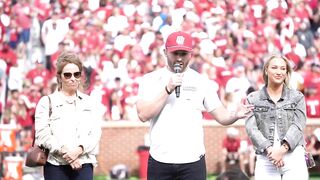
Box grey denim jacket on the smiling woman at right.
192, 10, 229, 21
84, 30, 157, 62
245, 86, 306, 154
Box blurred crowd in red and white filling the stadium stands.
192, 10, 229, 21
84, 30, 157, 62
0, 0, 320, 177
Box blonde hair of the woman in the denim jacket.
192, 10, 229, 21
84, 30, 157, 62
262, 54, 293, 87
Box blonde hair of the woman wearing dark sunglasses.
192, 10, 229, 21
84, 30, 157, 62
56, 51, 83, 90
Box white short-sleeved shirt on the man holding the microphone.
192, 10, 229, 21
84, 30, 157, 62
138, 68, 222, 163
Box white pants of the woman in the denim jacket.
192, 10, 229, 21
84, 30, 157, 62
255, 146, 309, 180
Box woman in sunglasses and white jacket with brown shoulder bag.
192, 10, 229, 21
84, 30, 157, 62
35, 52, 101, 180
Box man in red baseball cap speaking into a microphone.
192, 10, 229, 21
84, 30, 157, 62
136, 31, 252, 180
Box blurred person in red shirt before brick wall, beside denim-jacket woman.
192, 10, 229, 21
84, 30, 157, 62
221, 127, 240, 172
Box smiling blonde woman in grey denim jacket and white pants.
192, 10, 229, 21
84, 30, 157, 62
246, 55, 308, 180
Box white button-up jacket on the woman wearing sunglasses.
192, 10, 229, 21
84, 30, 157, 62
35, 91, 102, 165
